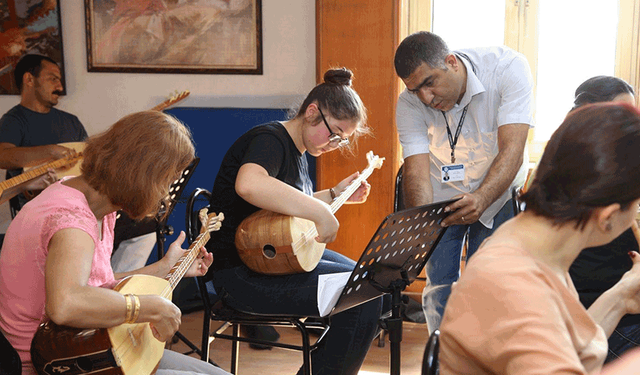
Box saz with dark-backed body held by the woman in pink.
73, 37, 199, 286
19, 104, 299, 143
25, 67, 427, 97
31, 208, 224, 375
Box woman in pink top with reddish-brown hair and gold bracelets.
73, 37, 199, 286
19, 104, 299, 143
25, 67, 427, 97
0, 111, 226, 375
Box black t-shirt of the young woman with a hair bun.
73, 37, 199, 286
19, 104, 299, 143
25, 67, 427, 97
207, 122, 313, 270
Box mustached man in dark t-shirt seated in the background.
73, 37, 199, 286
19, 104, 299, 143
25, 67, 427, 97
0, 55, 87, 209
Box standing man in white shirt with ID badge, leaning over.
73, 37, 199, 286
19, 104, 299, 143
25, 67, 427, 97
394, 32, 533, 331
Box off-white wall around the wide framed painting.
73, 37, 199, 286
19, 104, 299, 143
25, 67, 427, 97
0, 0, 316, 233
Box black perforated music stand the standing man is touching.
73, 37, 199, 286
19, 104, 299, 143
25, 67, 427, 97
329, 199, 457, 375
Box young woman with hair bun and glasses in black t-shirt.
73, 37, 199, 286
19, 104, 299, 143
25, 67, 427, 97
209, 68, 381, 375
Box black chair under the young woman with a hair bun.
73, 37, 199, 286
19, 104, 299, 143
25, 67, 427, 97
186, 188, 329, 375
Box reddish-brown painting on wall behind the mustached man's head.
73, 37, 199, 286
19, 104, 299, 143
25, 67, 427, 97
0, 0, 66, 95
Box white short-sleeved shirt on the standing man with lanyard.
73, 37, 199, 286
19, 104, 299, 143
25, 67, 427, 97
396, 47, 533, 228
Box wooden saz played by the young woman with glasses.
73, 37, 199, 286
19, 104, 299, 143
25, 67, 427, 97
235, 151, 384, 275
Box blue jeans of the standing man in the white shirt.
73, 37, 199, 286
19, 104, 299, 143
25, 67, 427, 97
422, 199, 514, 332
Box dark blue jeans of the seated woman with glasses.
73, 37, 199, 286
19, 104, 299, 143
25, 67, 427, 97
213, 250, 382, 375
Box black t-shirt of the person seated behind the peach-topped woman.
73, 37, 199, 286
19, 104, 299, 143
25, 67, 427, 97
569, 229, 640, 326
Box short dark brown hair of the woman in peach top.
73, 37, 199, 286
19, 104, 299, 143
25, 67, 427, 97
522, 102, 640, 229
